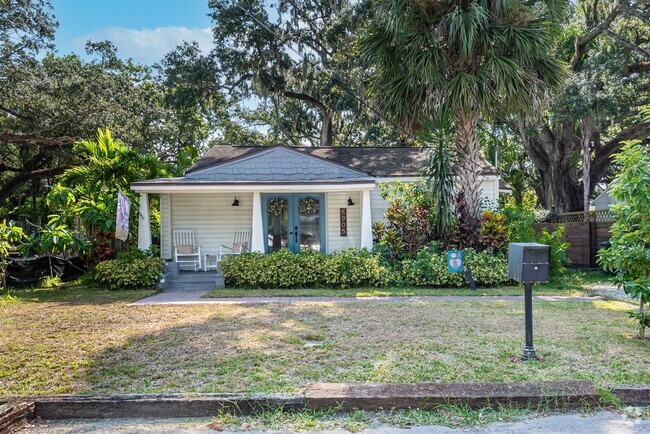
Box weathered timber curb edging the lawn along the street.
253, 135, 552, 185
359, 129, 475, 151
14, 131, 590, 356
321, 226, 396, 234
0, 380, 650, 422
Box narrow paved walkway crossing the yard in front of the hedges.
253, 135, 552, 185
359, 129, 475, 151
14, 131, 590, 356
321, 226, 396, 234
130, 291, 604, 306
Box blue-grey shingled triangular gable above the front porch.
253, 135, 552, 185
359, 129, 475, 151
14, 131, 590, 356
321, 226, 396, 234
185, 146, 368, 182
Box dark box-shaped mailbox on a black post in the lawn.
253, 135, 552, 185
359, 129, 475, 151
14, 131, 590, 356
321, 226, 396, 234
508, 243, 551, 360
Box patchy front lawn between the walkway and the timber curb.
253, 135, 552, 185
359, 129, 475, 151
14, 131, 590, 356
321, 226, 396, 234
0, 282, 650, 395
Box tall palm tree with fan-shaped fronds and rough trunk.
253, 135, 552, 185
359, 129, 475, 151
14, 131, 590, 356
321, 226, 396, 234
361, 0, 566, 217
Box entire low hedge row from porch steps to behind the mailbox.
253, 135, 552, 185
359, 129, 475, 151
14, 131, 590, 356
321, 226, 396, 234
221, 248, 509, 289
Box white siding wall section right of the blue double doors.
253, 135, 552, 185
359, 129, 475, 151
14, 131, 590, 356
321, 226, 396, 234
325, 191, 361, 253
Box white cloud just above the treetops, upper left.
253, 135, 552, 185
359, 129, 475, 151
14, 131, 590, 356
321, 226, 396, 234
72, 26, 213, 64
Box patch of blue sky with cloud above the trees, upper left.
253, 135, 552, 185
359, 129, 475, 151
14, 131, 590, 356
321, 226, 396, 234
51, 0, 213, 64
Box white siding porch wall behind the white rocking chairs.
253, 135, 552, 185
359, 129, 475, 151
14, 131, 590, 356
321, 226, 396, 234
161, 193, 253, 259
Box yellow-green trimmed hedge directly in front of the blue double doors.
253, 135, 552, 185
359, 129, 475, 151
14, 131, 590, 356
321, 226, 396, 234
221, 249, 387, 289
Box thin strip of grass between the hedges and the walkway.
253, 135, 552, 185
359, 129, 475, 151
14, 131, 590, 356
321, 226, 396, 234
203, 269, 607, 298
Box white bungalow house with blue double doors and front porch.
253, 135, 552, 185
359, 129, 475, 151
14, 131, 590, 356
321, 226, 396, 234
131, 146, 500, 274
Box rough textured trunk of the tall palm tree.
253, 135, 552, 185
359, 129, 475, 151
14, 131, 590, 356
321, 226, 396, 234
456, 110, 481, 218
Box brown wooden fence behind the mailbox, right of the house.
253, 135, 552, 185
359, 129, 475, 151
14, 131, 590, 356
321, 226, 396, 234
533, 220, 612, 268
